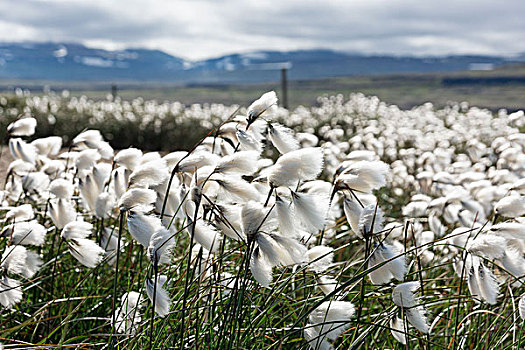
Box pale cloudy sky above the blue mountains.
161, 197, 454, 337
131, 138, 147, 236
0, 0, 525, 59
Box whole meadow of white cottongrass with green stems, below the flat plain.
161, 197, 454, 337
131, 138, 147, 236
0, 91, 525, 350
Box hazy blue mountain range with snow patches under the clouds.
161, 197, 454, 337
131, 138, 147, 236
0, 42, 525, 84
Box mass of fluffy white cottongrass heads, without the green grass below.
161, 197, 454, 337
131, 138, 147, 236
0, 92, 525, 349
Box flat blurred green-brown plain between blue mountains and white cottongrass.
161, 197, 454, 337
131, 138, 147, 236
4, 66, 525, 111
